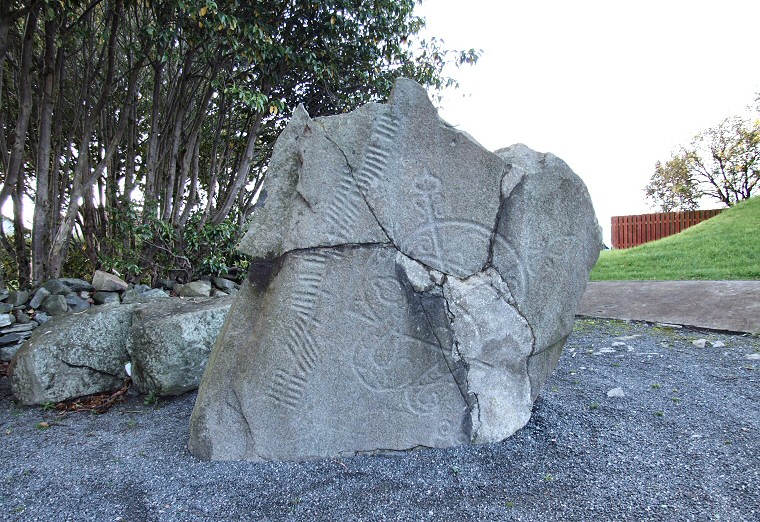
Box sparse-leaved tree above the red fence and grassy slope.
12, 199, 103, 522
645, 111, 760, 212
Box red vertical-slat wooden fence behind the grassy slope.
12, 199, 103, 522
612, 208, 724, 248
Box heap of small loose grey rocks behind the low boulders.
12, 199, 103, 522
0, 270, 239, 362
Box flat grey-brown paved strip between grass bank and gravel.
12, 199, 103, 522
578, 281, 760, 333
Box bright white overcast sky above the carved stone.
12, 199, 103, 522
417, 0, 760, 245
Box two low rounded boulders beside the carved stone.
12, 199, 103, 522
8, 297, 233, 405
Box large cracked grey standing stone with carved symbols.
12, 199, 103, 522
189, 79, 601, 460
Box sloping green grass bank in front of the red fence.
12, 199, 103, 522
590, 197, 760, 281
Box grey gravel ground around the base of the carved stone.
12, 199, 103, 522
0, 319, 760, 522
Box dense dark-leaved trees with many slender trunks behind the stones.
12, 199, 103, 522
0, 0, 478, 285
